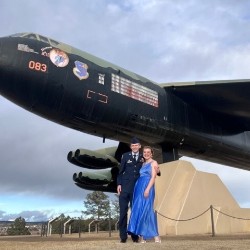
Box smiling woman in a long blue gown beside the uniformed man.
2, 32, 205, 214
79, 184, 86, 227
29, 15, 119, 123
128, 146, 161, 243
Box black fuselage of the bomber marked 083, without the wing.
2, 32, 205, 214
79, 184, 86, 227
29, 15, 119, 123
0, 34, 250, 169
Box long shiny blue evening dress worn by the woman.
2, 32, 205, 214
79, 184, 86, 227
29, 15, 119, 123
128, 162, 159, 240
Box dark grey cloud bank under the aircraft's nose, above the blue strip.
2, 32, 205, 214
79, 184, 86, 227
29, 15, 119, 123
0, 100, 115, 199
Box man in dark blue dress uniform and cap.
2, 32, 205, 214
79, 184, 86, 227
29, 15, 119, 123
117, 137, 143, 243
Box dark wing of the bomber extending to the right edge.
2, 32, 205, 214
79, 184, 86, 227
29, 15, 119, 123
161, 79, 250, 134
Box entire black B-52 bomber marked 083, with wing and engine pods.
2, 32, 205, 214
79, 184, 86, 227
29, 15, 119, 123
0, 33, 250, 192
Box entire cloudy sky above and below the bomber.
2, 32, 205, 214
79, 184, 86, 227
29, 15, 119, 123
0, 0, 250, 221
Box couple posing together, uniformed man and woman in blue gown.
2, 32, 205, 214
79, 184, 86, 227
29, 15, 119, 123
117, 138, 161, 243
